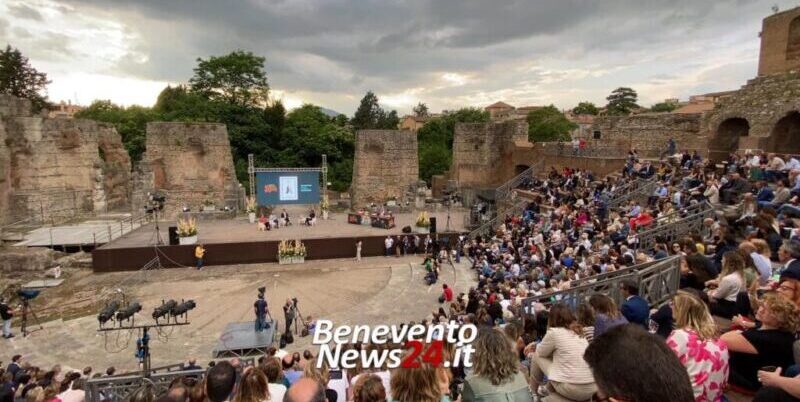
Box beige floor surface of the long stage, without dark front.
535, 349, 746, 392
102, 210, 465, 249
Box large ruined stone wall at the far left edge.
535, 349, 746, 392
0, 95, 131, 223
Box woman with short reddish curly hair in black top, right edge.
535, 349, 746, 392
720, 292, 800, 390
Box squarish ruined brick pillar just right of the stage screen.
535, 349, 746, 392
351, 130, 419, 208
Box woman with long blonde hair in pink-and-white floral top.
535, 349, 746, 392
667, 291, 728, 402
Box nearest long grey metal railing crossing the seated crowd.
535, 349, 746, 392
522, 256, 680, 312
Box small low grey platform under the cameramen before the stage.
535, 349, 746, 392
211, 320, 279, 358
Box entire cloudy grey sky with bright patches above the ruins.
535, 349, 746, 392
0, 0, 800, 115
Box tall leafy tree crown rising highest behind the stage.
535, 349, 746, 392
189, 50, 269, 107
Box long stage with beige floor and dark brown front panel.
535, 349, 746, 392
92, 210, 465, 272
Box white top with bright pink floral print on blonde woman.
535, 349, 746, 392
667, 329, 729, 402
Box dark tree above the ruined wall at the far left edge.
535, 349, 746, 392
0, 45, 50, 111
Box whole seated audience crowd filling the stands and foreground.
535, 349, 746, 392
0, 148, 800, 402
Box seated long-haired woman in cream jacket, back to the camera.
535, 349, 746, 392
530, 303, 597, 401
